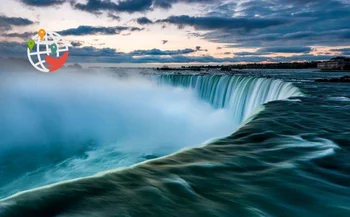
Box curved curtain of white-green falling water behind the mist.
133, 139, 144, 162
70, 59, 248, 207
158, 75, 303, 126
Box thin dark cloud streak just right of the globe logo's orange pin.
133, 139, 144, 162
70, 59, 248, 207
58, 26, 142, 35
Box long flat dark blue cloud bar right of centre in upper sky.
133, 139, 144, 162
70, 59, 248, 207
157, 15, 287, 30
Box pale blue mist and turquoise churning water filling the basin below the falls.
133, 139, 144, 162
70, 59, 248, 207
0, 72, 232, 197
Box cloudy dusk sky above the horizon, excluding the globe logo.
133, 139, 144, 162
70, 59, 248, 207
0, 0, 350, 64
